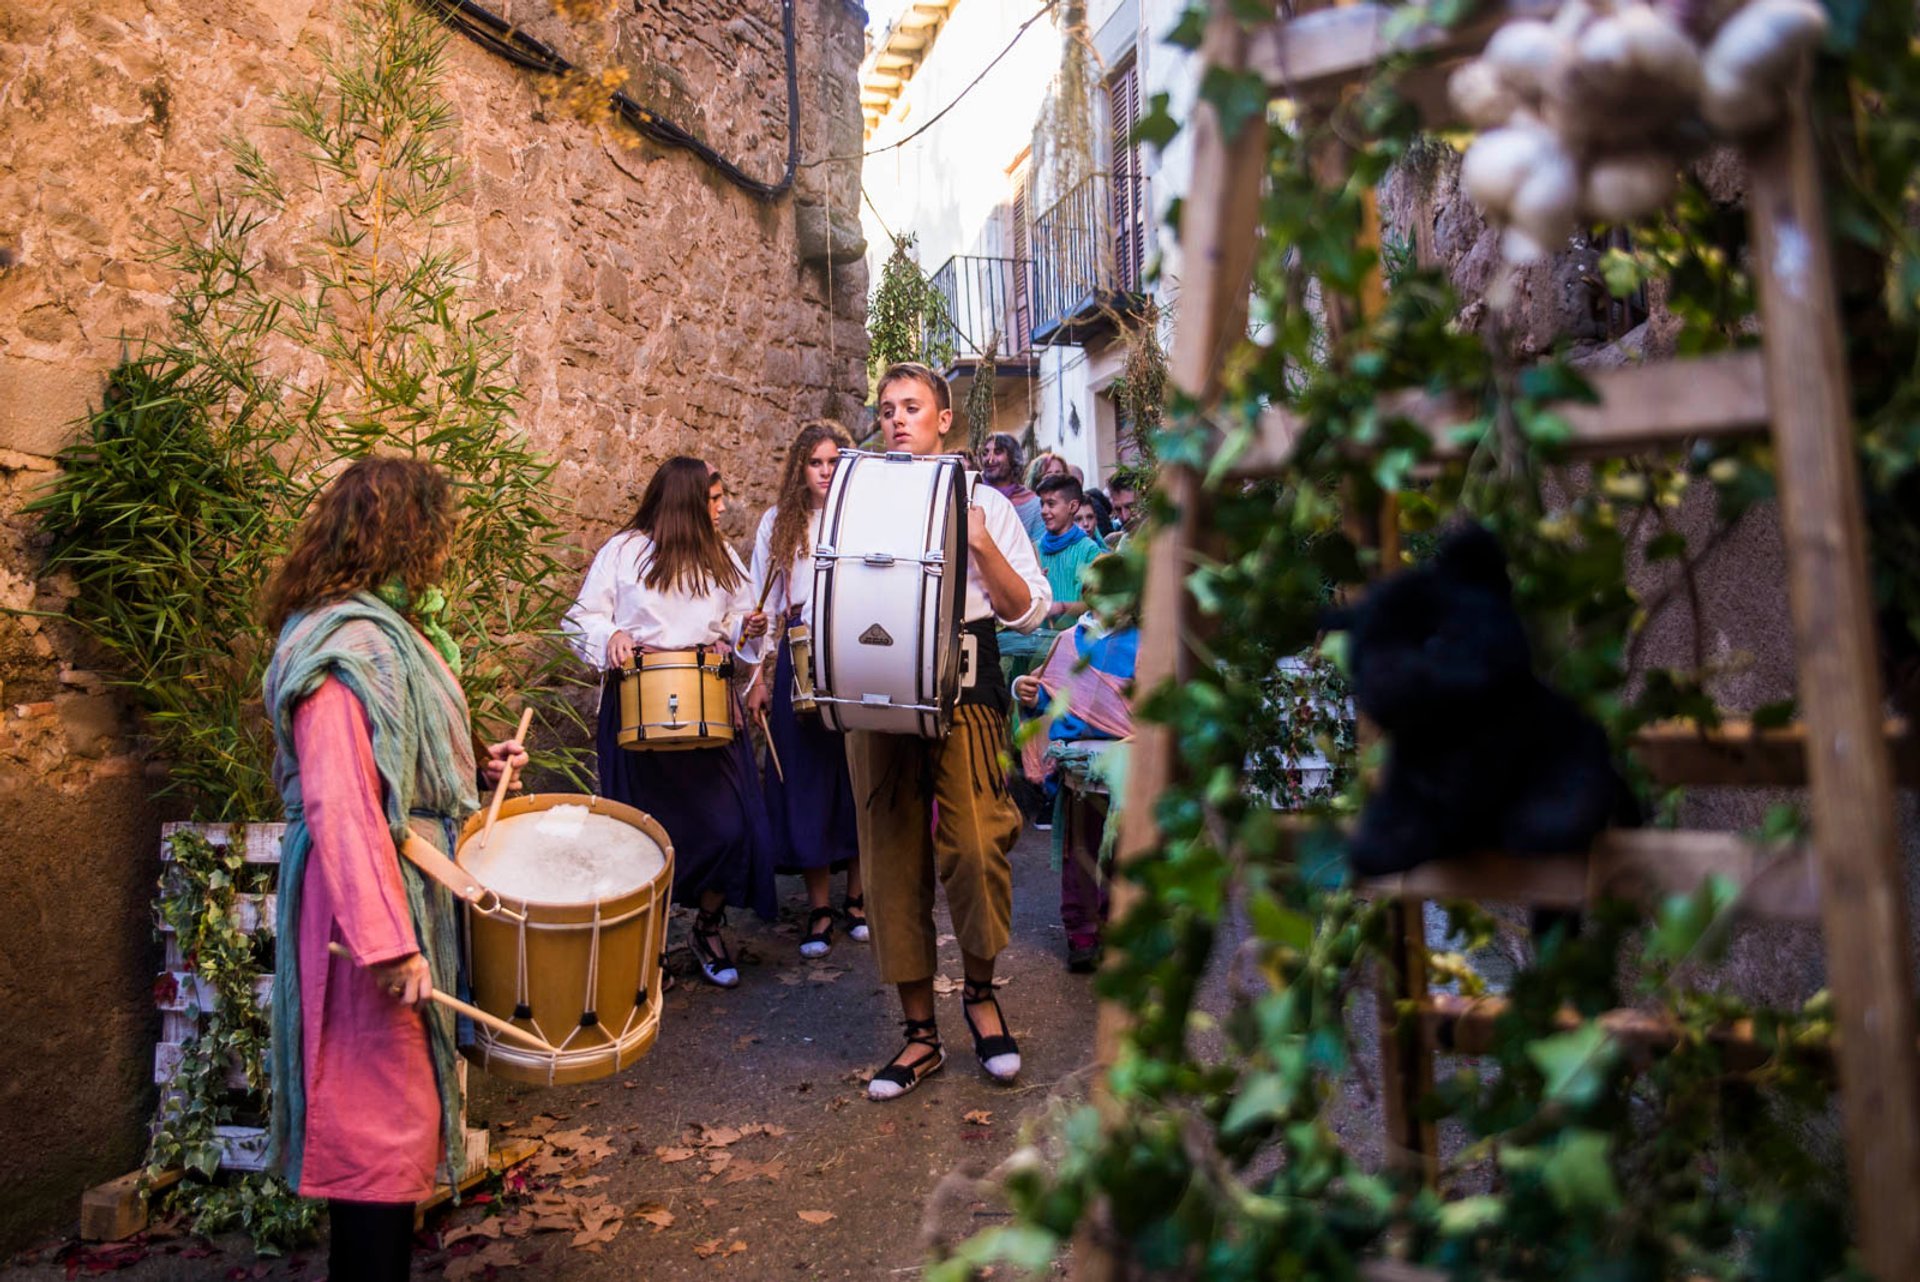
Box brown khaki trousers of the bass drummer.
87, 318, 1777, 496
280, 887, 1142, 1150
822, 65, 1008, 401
847, 704, 1021, 985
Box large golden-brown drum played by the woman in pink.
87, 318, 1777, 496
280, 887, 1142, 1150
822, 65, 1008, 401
459, 793, 674, 1086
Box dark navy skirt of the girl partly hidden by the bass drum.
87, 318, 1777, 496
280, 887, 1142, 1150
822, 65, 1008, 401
766, 637, 860, 873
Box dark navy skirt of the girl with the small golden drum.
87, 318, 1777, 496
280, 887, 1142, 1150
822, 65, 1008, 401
593, 681, 776, 921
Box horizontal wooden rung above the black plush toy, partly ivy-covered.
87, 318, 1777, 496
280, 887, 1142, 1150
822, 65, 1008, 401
1233, 351, 1768, 478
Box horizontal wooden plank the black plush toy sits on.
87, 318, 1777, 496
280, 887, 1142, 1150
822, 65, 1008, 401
1359, 829, 1820, 921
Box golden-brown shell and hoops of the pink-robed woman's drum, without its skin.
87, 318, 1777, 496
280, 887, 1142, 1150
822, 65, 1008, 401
459, 793, 674, 1086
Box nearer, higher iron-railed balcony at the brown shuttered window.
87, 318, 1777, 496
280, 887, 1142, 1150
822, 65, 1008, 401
1031, 173, 1146, 347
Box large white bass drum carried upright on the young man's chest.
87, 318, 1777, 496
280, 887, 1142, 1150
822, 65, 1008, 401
812, 451, 968, 739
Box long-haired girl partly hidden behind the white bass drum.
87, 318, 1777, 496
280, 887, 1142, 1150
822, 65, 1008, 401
747, 418, 868, 958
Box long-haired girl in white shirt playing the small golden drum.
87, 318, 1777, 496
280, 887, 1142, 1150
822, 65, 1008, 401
563, 457, 774, 988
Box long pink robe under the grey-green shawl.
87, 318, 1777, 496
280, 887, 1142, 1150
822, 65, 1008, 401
294, 677, 442, 1203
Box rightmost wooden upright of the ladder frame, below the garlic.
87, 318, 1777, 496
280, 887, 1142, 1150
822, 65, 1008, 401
1747, 102, 1920, 1278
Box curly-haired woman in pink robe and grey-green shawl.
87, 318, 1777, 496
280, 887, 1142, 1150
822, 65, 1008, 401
265, 459, 526, 1278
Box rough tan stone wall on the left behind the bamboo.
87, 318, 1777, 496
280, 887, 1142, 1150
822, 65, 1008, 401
0, 0, 866, 1249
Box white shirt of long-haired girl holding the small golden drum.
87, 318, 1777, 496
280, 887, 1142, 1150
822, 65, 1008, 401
561, 530, 755, 668
